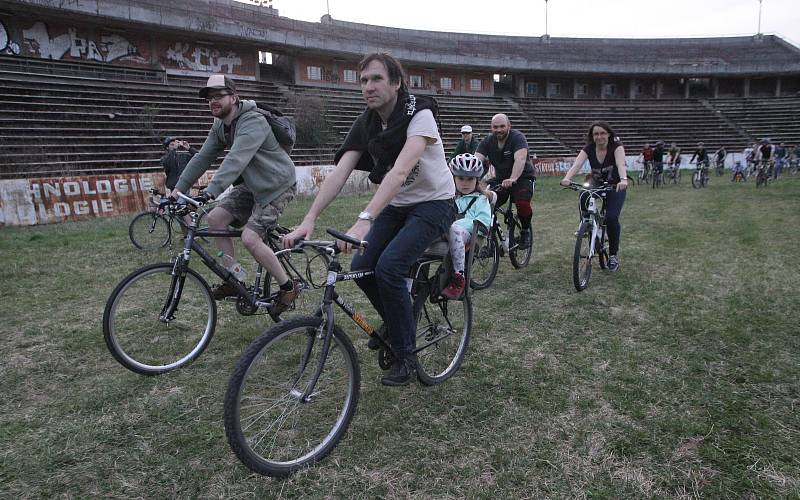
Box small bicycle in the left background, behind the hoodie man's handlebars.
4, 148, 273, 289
128, 188, 207, 250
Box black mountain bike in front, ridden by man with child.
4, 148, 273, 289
224, 229, 475, 477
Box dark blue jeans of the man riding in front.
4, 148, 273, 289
351, 199, 456, 356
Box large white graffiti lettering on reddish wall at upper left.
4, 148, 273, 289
22, 21, 148, 64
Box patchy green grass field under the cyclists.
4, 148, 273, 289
0, 175, 800, 498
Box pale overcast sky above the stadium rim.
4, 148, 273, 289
273, 0, 800, 46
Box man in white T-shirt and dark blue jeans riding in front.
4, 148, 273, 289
284, 53, 455, 386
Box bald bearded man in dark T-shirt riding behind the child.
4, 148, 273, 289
475, 113, 536, 248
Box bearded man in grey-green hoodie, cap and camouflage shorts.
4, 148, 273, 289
175, 75, 298, 314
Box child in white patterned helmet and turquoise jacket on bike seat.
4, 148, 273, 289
442, 153, 493, 299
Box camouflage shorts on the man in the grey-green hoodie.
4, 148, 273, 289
217, 184, 297, 239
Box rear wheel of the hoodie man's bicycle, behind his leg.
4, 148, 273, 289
261, 247, 330, 317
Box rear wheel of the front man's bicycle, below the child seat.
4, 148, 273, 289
414, 291, 472, 385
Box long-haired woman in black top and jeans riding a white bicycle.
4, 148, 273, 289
561, 122, 628, 272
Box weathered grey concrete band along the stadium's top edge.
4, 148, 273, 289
6, 0, 800, 76
